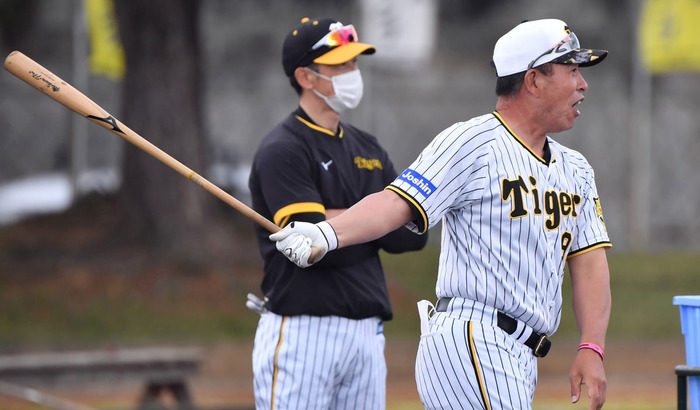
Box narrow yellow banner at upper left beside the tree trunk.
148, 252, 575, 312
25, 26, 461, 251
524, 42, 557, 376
85, 0, 126, 80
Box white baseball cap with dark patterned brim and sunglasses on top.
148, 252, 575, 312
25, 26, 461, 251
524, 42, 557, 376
493, 19, 608, 77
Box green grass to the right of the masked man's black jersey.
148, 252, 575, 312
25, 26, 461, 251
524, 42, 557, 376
382, 243, 700, 340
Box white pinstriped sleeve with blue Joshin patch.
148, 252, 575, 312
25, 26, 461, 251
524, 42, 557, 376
387, 117, 493, 233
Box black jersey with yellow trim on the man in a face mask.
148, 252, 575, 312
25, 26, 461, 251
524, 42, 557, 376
249, 109, 426, 320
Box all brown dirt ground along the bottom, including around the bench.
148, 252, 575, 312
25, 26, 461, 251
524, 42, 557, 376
0, 339, 685, 410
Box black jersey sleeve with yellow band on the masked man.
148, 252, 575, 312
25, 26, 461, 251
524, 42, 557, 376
255, 141, 326, 227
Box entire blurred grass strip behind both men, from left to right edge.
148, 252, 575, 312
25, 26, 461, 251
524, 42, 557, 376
0, 242, 700, 350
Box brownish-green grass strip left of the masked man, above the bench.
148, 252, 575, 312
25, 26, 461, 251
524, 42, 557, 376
0, 273, 258, 350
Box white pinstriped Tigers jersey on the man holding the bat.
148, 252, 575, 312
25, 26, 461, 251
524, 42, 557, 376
388, 112, 612, 335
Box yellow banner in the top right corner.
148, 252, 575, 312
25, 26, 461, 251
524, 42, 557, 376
639, 0, 700, 74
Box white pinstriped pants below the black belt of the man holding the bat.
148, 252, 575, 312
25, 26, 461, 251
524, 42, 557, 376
416, 304, 537, 410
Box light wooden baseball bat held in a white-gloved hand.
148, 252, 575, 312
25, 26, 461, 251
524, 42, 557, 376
5, 51, 280, 233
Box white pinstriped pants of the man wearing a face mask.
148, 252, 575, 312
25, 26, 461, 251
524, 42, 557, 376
253, 312, 386, 410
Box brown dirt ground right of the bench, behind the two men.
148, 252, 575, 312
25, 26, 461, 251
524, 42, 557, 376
194, 339, 685, 410
